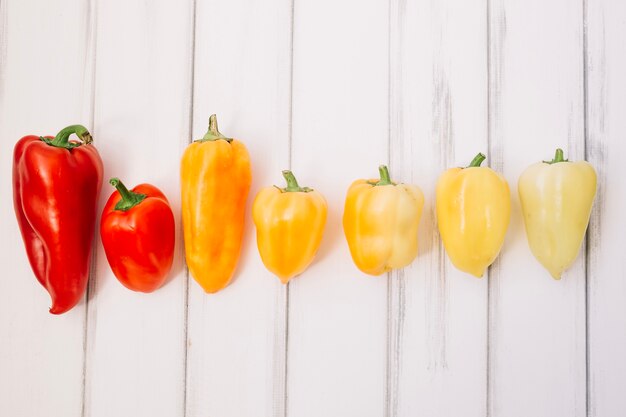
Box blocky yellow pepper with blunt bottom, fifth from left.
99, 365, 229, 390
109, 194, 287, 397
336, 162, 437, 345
343, 165, 424, 275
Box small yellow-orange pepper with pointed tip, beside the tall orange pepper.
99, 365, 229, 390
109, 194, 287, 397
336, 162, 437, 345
252, 171, 328, 284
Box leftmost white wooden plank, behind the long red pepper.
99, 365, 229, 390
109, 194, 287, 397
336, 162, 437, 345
0, 0, 94, 417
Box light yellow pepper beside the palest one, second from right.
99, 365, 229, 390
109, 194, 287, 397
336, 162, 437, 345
436, 153, 511, 278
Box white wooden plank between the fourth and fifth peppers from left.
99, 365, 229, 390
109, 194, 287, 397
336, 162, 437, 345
287, 0, 389, 417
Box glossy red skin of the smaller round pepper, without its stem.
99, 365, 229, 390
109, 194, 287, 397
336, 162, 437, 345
100, 184, 176, 292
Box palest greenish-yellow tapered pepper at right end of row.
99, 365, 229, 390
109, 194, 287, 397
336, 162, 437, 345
518, 149, 596, 279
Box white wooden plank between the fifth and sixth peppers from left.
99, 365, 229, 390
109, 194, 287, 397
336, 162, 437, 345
386, 0, 490, 416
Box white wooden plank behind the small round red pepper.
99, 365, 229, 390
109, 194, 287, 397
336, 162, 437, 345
85, 0, 193, 417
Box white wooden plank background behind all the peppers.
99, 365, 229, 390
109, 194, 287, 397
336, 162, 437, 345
0, 0, 626, 417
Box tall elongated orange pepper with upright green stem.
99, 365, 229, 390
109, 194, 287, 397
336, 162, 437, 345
180, 115, 252, 293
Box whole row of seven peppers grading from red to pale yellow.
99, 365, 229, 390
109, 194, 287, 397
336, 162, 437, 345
13, 115, 596, 314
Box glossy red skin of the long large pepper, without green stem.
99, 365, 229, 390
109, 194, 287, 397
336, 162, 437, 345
13, 136, 102, 314
